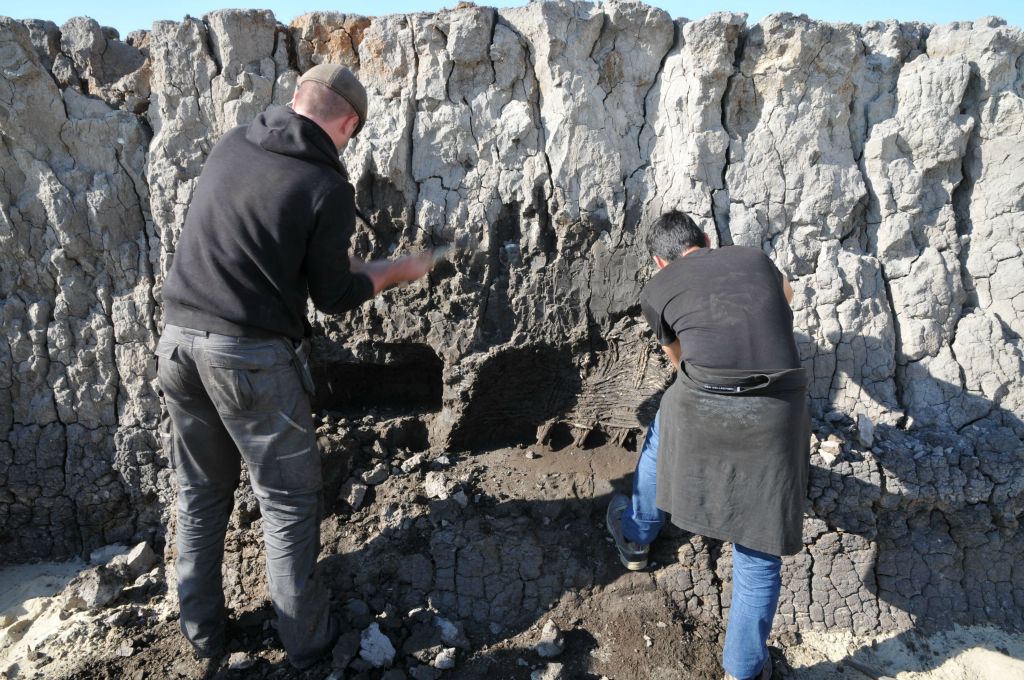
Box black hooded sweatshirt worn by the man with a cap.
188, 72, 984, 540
164, 107, 373, 339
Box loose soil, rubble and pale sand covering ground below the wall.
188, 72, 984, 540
8, 413, 1024, 680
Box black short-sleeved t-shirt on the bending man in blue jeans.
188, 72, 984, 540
640, 246, 800, 370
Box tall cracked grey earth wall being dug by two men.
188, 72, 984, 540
0, 2, 1024, 633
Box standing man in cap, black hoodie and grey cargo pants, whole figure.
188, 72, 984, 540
157, 65, 431, 668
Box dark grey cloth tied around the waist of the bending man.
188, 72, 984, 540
657, 364, 810, 555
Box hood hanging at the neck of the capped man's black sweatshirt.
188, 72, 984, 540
246, 107, 345, 175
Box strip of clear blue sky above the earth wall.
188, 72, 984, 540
0, 0, 1024, 37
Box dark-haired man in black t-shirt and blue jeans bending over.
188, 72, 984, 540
607, 212, 810, 680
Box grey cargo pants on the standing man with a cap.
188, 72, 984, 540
157, 325, 337, 667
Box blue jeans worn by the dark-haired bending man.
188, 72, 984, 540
623, 411, 782, 678
